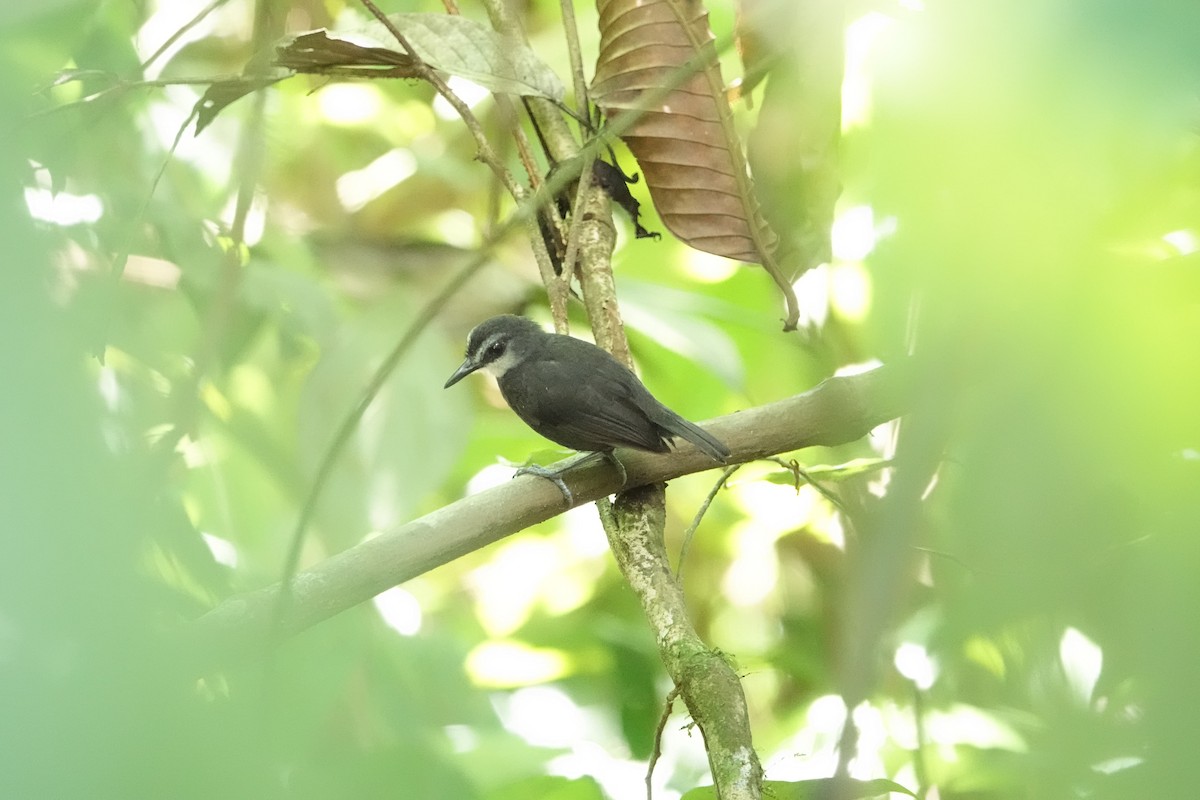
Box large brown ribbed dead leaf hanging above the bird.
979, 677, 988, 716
592, 0, 799, 330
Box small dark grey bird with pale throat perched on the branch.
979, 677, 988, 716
445, 314, 731, 505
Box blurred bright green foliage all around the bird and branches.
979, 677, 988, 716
0, 0, 1200, 800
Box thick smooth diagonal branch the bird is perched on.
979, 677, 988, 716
193, 366, 908, 661
